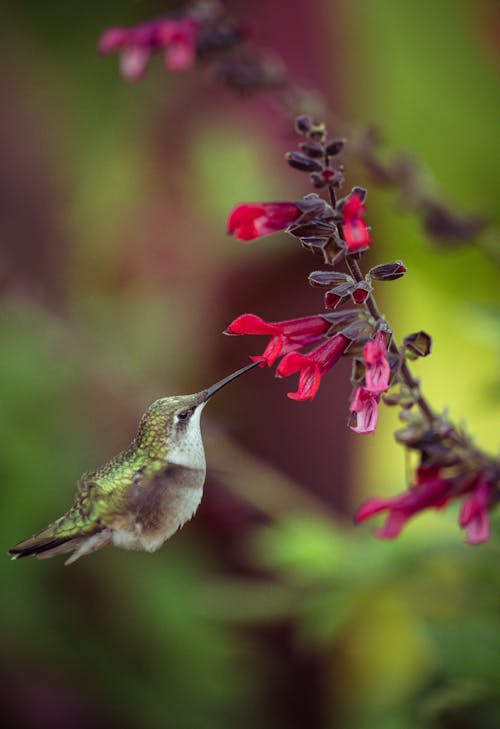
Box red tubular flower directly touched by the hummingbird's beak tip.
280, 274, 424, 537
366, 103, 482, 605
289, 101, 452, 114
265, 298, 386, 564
224, 314, 330, 367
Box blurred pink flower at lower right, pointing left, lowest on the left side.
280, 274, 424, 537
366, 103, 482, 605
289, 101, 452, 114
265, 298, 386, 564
355, 467, 453, 539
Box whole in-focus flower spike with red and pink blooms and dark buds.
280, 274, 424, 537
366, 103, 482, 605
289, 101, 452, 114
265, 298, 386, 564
226, 117, 500, 544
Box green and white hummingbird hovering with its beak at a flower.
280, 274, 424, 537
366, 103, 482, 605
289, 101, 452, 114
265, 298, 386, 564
9, 362, 258, 564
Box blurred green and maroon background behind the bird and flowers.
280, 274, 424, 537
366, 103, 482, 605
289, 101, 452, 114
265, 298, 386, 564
0, 0, 500, 729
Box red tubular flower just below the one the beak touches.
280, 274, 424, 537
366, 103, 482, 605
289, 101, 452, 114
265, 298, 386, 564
276, 334, 349, 400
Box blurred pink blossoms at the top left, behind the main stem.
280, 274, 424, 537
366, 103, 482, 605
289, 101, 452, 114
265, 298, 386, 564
99, 16, 198, 81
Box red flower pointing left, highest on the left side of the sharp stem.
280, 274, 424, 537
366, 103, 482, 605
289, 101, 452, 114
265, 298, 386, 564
227, 202, 302, 240
